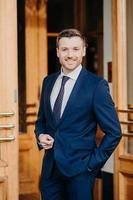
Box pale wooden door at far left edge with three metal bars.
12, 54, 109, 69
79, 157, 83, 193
0, 0, 18, 200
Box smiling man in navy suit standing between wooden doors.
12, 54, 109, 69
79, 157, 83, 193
35, 29, 121, 200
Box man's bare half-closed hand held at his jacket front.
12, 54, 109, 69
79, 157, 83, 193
39, 134, 54, 149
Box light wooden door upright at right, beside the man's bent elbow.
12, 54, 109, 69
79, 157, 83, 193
112, 0, 127, 200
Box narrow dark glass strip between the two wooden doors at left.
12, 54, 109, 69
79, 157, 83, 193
17, 0, 26, 133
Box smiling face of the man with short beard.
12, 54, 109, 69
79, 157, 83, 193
57, 36, 86, 74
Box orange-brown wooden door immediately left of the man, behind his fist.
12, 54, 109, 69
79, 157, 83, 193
19, 0, 47, 195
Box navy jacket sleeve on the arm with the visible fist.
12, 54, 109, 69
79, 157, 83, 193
34, 79, 46, 149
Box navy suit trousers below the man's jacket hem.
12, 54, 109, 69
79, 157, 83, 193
40, 162, 95, 200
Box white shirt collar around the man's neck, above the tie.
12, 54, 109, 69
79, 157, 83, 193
60, 64, 82, 80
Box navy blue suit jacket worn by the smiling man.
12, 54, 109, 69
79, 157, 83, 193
35, 68, 121, 177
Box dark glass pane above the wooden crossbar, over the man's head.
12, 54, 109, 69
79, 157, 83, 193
47, 0, 74, 32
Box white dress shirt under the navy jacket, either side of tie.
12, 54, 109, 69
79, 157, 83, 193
50, 65, 82, 116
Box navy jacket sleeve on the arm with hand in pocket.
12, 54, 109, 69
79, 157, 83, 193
88, 80, 121, 170
